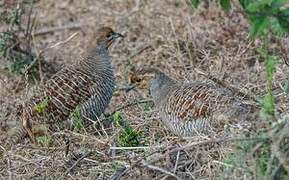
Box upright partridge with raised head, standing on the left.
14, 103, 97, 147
5, 27, 124, 144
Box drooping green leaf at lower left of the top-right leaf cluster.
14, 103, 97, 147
250, 16, 270, 38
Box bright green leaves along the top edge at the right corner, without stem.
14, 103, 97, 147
191, 0, 289, 35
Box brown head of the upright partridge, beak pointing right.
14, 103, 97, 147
96, 27, 124, 48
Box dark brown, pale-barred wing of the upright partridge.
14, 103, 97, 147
30, 67, 93, 122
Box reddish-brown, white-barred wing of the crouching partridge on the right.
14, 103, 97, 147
165, 83, 233, 121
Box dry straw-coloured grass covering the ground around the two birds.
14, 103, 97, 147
0, 0, 289, 179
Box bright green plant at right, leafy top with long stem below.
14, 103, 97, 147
235, 0, 289, 119
